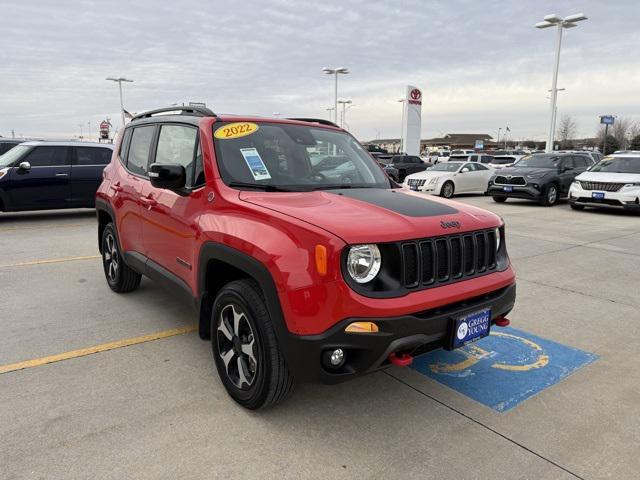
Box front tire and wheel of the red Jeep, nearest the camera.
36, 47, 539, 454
211, 280, 293, 410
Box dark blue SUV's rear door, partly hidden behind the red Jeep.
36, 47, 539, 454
70, 146, 113, 207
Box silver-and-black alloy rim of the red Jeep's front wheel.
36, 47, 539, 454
216, 303, 258, 390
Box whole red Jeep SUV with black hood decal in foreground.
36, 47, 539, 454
96, 107, 515, 409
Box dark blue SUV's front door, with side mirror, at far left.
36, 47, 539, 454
8, 145, 71, 210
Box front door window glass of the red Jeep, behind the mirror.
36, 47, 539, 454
155, 125, 198, 187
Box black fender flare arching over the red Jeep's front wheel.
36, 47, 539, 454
198, 242, 291, 365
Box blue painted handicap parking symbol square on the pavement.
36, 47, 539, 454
411, 327, 598, 412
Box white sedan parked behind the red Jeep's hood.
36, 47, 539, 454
403, 161, 494, 198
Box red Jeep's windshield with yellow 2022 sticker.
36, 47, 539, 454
213, 122, 391, 191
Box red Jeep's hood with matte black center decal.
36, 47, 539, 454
240, 188, 501, 244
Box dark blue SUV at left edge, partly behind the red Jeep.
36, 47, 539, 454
0, 142, 113, 212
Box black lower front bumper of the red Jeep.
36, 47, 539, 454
284, 283, 516, 384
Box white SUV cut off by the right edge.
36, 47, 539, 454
569, 153, 640, 211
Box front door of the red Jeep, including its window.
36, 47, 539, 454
141, 124, 201, 285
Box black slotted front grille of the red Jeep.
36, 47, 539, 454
401, 230, 497, 288
